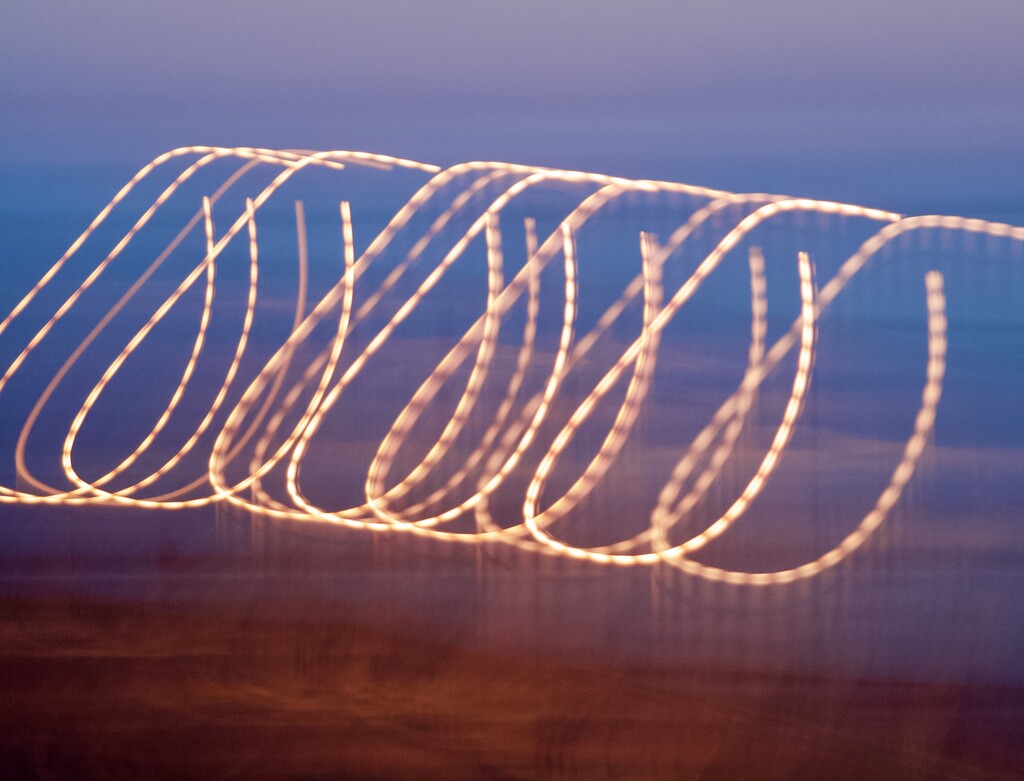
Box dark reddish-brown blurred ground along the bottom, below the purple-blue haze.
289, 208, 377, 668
0, 599, 1024, 779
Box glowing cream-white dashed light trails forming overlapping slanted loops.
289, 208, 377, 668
0, 146, 1024, 585
